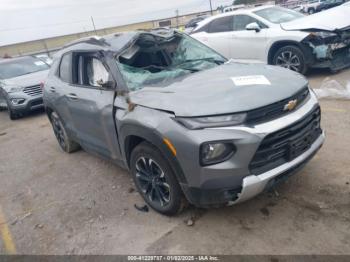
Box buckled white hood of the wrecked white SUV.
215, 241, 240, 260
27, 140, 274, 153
281, 5, 350, 31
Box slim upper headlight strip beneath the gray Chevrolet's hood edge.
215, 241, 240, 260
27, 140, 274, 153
175, 113, 247, 129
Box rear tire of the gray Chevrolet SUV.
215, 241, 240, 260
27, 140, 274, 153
50, 112, 80, 153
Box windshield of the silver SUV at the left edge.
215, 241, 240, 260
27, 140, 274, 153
0, 56, 50, 80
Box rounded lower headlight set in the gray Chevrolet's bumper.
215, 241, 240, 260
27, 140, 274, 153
200, 142, 236, 166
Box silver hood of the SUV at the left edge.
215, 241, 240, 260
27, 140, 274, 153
1, 70, 49, 89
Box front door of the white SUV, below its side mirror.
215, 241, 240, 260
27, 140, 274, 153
230, 14, 269, 62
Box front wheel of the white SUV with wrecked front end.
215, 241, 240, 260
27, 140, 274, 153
272, 45, 308, 74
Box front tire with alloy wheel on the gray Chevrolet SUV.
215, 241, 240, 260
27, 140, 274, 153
130, 142, 185, 216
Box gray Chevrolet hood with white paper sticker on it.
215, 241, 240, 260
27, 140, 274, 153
130, 62, 307, 117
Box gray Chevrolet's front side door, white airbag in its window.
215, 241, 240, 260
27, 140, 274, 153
65, 52, 121, 159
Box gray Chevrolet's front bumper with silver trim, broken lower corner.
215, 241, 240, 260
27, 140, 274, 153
179, 93, 325, 207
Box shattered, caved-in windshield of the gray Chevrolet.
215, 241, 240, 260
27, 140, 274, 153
117, 34, 226, 91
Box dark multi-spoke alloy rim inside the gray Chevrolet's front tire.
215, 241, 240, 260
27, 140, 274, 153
136, 157, 170, 207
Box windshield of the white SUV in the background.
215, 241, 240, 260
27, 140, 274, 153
254, 7, 304, 24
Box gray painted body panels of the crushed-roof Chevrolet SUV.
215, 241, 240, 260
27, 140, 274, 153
44, 30, 326, 207
